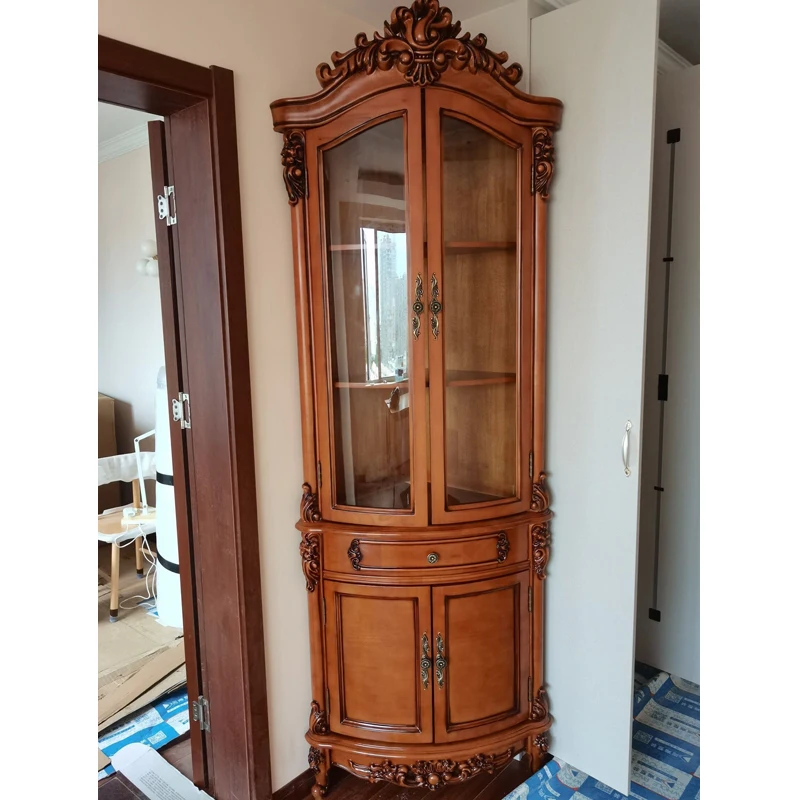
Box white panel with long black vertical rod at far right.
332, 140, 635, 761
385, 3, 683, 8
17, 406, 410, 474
636, 66, 700, 683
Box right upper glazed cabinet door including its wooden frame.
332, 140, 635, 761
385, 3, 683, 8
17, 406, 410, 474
427, 93, 532, 522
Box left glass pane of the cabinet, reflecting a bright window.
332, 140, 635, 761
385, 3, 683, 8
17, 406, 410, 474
323, 119, 411, 509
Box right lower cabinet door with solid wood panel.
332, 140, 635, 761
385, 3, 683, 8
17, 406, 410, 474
432, 570, 530, 742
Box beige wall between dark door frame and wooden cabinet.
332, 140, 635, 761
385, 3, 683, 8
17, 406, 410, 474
99, 0, 374, 789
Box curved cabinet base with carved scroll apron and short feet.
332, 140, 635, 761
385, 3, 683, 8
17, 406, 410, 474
306, 719, 551, 800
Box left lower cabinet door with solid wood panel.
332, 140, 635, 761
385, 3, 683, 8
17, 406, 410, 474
325, 581, 435, 743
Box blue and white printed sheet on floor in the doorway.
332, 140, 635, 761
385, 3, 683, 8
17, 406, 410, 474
97, 687, 189, 780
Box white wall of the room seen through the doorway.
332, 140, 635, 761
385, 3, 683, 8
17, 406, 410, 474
97, 147, 164, 450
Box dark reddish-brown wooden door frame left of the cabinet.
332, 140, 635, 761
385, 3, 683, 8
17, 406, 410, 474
98, 36, 271, 800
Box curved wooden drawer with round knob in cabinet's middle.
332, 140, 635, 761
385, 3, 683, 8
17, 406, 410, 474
324, 525, 528, 574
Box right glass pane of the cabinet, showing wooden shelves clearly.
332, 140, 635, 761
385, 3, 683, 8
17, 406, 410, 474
441, 116, 519, 507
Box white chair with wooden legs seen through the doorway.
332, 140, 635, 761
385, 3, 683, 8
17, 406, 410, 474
97, 452, 156, 622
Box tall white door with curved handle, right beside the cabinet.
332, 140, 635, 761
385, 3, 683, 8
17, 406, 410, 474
530, 0, 658, 794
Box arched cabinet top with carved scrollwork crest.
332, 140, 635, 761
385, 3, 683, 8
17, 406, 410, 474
270, 0, 562, 132
